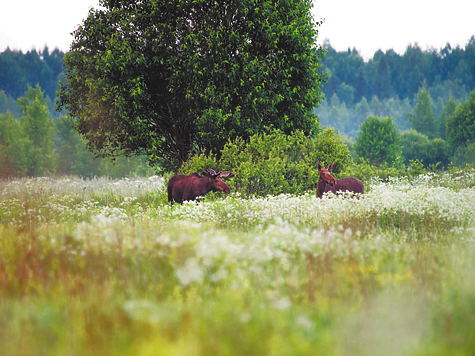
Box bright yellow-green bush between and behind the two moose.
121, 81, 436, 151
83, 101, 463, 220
180, 129, 350, 196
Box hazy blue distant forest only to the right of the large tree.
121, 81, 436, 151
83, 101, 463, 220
316, 36, 475, 138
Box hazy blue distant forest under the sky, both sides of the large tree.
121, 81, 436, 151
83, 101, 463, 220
0, 36, 475, 138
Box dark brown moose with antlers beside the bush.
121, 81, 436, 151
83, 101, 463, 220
168, 169, 234, 206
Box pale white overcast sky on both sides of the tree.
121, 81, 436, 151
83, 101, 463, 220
0, 0, 475, 60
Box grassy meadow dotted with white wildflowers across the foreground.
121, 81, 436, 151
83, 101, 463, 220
0, 170, 475, 356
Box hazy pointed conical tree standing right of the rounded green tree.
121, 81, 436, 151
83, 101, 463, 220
408, 89, 438, 139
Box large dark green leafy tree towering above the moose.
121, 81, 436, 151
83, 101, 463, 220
54, 0, 323, 171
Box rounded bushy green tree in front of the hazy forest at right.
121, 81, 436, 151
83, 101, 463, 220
355, 116, 401, 165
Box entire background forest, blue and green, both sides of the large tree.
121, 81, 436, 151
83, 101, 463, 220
0, 36, 475, 178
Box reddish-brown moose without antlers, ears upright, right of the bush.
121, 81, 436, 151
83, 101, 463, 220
317, 162, 364, 198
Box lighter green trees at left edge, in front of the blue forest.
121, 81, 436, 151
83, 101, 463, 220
0, 85, 153, 178
